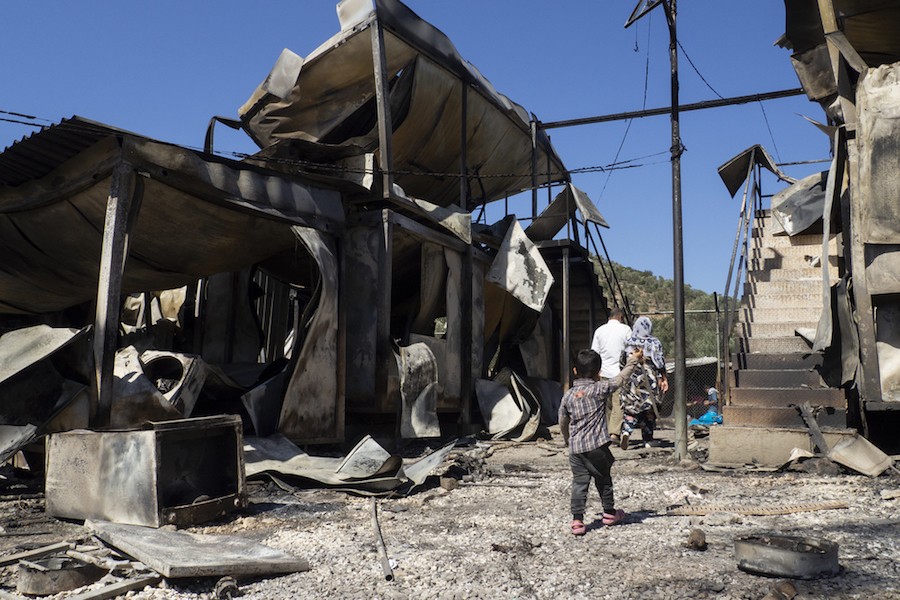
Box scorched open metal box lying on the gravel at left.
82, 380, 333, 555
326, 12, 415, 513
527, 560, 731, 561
46, 416, 247, 527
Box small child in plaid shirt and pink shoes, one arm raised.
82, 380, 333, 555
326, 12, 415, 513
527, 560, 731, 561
559, 349, 643, 535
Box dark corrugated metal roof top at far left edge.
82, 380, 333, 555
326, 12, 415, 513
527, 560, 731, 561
0, 116, 135, 187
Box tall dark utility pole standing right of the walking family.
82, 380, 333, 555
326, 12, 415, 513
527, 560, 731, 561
625, 0, 688, 460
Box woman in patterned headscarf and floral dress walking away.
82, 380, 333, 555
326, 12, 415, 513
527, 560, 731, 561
620, 317, 669, 450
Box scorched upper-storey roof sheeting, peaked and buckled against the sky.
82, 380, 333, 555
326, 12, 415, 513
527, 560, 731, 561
239, 0, 566, 208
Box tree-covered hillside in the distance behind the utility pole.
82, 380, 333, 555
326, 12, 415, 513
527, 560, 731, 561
594, 258, 724, 358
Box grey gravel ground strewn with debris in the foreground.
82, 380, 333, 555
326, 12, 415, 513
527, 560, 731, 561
0, 424, 900, 600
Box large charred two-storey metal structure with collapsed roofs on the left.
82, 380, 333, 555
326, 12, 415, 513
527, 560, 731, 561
0, 0, 606, 451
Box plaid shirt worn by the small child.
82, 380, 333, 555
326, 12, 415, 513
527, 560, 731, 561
559, 378, 618, 454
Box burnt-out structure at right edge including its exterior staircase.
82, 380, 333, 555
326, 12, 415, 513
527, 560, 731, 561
710, 0, 900, 460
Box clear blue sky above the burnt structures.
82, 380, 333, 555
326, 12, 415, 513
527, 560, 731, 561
0, 0, 829, 296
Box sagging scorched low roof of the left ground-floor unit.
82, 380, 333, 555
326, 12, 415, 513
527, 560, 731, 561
0, 123, 344, 314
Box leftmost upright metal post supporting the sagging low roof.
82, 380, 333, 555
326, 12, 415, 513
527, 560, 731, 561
90, 161, 143, 429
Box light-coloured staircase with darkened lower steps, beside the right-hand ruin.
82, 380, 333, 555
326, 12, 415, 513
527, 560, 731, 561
709, 210, 847, 466
